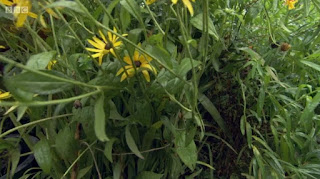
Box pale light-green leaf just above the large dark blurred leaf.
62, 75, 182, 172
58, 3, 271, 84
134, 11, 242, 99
26, 51, 56, 70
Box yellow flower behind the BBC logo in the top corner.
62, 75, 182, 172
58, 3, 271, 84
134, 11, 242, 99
0, 0, 38, 27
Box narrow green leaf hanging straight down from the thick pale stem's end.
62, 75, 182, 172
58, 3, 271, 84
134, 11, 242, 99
94, 94, 109, 142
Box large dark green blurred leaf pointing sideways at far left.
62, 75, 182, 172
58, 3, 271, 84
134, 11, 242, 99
5, 71, 72, 94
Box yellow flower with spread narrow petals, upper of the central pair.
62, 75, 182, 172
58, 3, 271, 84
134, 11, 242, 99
86, 28, 128, 65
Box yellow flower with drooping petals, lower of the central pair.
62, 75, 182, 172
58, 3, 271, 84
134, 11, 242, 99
116, 45, 157, 82
